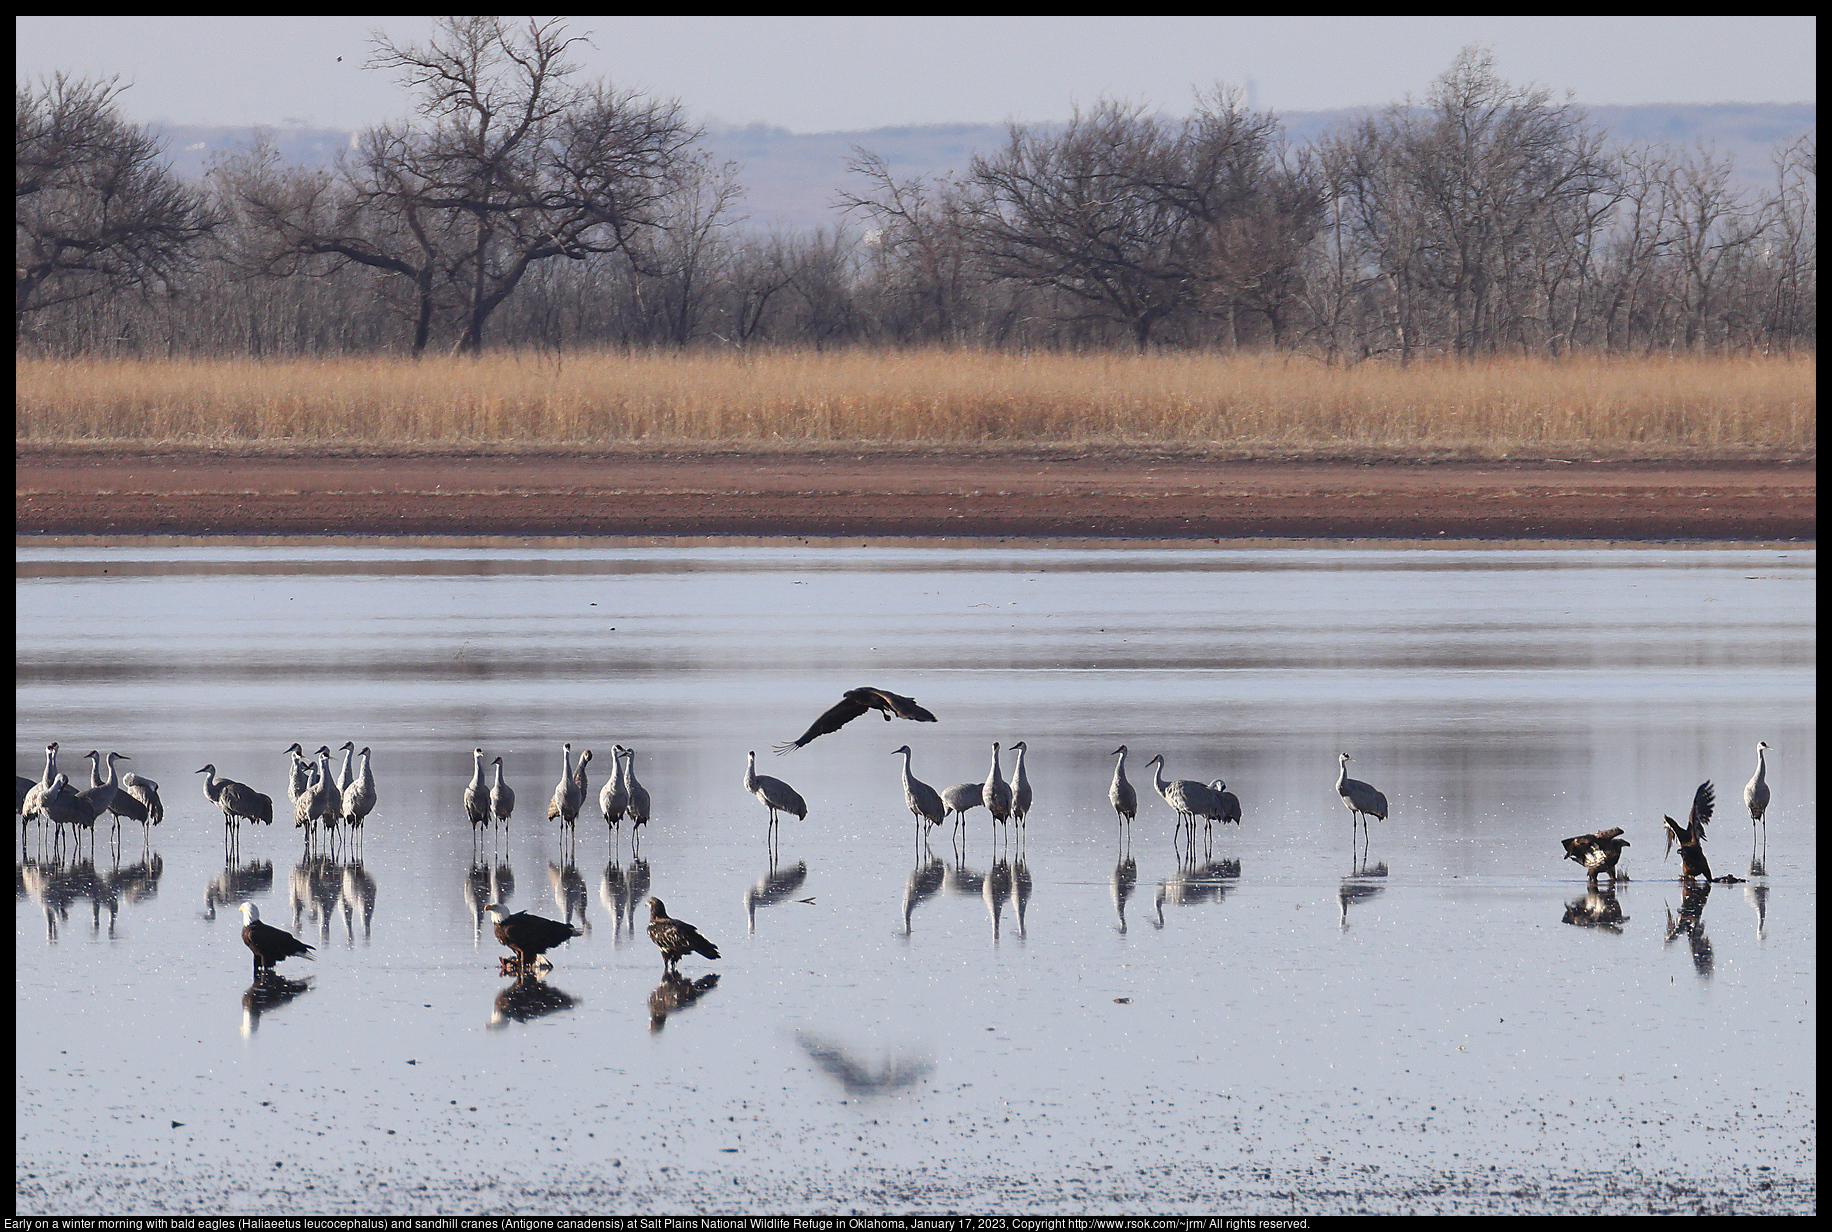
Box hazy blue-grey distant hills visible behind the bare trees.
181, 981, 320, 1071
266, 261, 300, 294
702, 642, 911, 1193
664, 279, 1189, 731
154, 103, 1819, 229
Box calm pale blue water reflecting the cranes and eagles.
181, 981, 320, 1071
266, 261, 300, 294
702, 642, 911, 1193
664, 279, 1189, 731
15, 548, 1817, 1214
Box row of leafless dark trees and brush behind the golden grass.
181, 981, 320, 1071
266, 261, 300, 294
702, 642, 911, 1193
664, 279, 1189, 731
16, 33, 1817, 361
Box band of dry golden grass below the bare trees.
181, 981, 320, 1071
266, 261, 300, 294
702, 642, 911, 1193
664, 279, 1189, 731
15, 350, 1817, 457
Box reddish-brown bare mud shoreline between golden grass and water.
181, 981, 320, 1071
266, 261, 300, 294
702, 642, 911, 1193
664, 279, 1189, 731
15, 447, 1817, 543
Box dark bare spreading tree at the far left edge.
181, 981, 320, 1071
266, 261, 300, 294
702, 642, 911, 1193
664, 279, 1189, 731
13, 73, 216, 326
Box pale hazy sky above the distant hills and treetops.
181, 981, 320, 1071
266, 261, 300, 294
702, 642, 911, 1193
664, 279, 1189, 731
15, 17, 1817, 132
